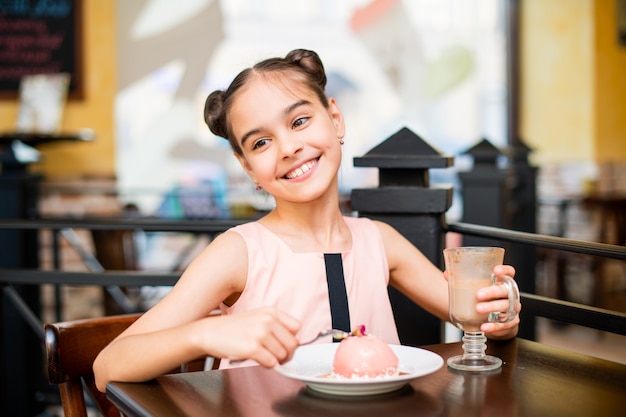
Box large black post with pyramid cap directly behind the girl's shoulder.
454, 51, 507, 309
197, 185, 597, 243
351, 128, 453, 346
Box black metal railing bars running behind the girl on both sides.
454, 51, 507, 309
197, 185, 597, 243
0, 219, 626, 335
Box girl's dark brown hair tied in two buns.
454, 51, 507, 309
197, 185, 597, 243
204, 49, 328, 155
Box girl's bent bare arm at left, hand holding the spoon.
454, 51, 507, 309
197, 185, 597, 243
93, 232, 300, 391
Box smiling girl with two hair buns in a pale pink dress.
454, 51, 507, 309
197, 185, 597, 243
94, 50, 520, 391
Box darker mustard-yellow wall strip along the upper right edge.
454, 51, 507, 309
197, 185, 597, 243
594, 0, 626, 162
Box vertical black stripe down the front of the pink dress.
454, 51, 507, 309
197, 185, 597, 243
324, 253, 350, 342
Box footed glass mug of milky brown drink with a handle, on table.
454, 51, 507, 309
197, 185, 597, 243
443, 246, 519, 371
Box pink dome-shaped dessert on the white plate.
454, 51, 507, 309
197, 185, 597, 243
332, 326, 398, 379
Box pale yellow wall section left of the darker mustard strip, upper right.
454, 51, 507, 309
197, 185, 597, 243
520, 0, 594, 163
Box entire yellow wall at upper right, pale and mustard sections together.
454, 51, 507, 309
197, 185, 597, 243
520, 0, 626, 164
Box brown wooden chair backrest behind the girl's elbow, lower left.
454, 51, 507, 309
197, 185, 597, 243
44, 313, 141, 417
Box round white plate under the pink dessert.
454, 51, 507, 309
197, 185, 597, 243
274, 343, 443, 396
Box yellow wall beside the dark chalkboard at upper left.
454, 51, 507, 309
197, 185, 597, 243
0, 0, 117, 179
